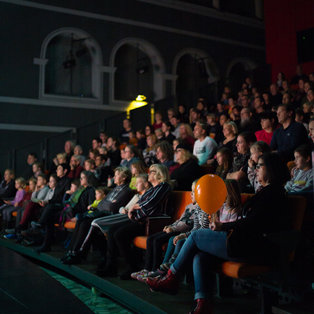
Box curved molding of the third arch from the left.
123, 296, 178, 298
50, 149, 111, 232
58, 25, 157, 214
172, 48, 219, 95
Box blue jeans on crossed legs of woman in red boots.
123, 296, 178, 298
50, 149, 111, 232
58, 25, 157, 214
170, 229, 230, 299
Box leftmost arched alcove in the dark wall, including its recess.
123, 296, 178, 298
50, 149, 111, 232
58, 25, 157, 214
39, 28, 102, 102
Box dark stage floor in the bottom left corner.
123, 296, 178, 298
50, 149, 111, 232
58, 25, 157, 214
0, 246, 92, 314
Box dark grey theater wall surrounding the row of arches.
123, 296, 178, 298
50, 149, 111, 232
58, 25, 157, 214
0, 0, 265, 172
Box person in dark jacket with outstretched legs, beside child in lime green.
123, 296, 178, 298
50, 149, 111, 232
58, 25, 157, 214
62, 167, 133, 264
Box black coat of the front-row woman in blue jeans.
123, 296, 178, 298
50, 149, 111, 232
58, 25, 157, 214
222, 185, 291, 261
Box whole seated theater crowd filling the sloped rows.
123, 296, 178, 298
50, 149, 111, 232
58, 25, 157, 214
0, 67, 314, 313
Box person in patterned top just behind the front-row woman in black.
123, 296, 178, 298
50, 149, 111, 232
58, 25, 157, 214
247, 141, 271, 193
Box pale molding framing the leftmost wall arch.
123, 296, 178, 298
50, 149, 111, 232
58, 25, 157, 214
34, 27, 103, 104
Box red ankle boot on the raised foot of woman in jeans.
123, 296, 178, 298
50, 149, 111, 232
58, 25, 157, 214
146, 269, 180, 294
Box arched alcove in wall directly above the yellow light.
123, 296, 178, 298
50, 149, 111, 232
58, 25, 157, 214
110, 38, 164, 102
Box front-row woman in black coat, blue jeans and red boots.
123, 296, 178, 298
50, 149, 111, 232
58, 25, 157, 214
147, 154, 289, 313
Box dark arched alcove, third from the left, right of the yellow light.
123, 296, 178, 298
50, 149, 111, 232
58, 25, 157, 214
172, 48, 219, 107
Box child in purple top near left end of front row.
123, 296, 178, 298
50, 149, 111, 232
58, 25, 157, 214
0, 177, 26, 228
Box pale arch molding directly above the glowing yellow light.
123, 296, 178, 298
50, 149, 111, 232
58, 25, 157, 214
109, 37, 166, 105
